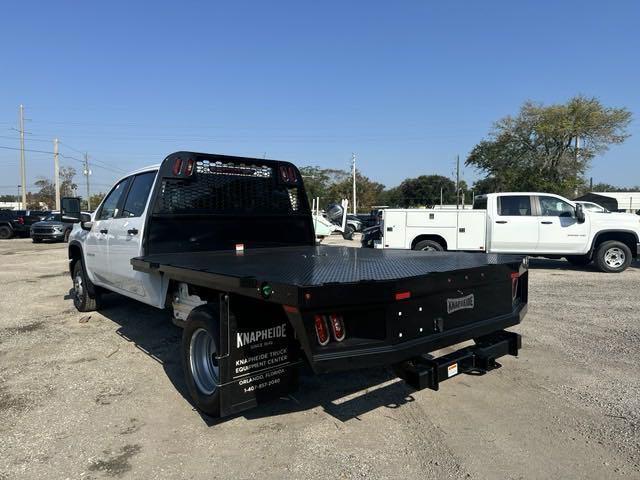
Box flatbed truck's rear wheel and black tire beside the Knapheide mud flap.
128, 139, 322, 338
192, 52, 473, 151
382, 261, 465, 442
182, 304, 220, 418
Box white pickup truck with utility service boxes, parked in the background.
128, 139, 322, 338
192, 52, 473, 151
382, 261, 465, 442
362, 192, 640, 272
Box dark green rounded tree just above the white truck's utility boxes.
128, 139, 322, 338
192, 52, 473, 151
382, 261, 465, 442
398, 175, 456, 207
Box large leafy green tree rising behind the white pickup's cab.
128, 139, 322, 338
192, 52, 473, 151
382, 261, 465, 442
466, 96, 631, 195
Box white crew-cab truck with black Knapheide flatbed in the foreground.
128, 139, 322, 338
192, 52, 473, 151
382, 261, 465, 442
63, 152, 528, 416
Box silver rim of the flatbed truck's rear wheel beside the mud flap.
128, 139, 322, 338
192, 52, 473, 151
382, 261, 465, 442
189, 328, 219, 395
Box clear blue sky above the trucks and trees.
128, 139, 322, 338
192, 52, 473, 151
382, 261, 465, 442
0, 0, 640, 193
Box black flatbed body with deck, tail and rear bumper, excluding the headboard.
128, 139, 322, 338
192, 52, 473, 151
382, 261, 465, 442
131, 246, 527, 413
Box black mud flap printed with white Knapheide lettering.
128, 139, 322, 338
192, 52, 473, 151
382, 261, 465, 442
218, 295, 300, 416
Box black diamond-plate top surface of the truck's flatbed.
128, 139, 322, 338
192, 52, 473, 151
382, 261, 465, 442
135, 246, 521, 287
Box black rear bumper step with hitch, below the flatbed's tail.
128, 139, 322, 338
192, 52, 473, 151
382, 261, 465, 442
393, 330, 522, 390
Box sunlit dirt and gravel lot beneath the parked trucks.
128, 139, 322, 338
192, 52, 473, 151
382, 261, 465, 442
0, 239, 640, 480
